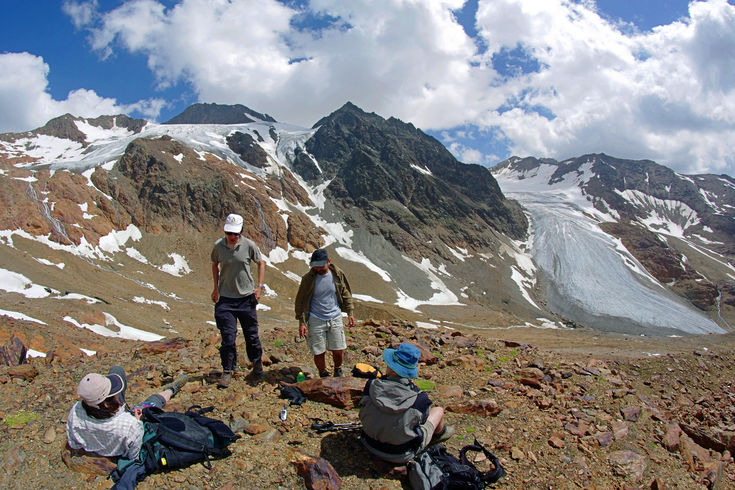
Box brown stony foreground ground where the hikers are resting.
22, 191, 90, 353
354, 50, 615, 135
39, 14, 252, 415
0, 321, 735, 489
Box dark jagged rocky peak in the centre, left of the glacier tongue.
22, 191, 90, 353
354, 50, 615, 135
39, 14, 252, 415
294, 98, 527, 259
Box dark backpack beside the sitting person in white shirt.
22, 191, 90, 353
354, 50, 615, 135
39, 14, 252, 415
139, 406, 240, 474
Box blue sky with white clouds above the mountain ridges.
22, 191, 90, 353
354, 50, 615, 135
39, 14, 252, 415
0, 0, 735, 176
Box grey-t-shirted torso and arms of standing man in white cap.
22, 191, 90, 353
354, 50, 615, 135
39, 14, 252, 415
212, 237, 261, 298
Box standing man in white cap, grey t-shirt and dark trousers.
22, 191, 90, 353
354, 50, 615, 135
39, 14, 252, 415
212, 214, 265, 388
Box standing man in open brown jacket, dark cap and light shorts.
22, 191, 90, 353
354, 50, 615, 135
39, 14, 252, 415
294, 248, 355, 378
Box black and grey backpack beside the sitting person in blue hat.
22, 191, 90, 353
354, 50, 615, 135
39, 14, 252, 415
407, 439, 505, 490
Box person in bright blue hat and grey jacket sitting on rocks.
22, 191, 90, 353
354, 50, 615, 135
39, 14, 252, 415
360, 343, 454, 464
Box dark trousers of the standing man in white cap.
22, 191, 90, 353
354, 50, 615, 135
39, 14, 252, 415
214, 294, 263, 372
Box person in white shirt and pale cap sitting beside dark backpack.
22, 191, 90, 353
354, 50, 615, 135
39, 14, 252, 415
66, 366, 188, 459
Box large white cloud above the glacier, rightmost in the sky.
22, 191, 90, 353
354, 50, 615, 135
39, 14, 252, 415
478, 0, 735, 174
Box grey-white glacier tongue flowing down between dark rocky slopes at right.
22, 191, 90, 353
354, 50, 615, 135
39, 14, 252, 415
494, 165, 725, 335
